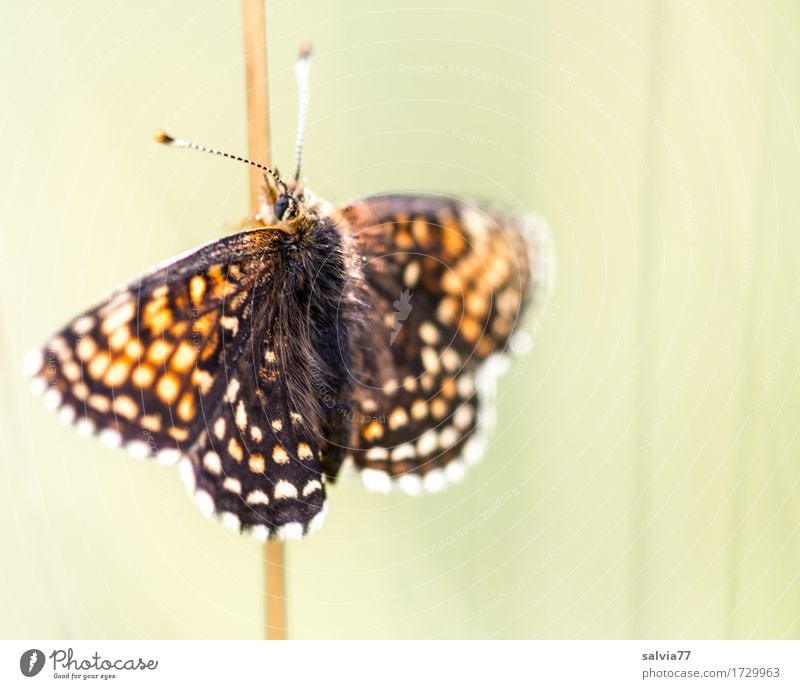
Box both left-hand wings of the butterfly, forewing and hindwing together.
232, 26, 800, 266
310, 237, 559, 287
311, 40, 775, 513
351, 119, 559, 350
26, 229, 324, 538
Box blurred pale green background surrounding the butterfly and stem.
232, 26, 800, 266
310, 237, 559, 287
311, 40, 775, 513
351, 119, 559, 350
0, 0, 800, 638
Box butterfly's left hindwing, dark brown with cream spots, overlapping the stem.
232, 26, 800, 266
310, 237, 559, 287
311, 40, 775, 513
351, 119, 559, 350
180, 330, 325, 540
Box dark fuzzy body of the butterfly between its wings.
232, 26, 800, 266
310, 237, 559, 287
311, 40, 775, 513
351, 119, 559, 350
261, 194, 361, 479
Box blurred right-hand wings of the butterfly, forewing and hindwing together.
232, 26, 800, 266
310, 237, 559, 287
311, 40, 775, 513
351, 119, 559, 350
342, 195, 554, 494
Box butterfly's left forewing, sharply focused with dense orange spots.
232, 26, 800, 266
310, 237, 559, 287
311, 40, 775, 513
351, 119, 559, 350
26, 231, 276, 461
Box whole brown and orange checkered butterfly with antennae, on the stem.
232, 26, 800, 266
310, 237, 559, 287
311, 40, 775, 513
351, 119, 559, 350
25, 45, 554, 540
